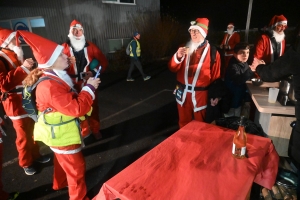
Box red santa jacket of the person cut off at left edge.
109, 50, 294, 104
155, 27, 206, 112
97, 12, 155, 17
0, 49, 30, 120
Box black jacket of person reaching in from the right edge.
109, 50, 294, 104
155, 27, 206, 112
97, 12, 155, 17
256, 38, 300, 167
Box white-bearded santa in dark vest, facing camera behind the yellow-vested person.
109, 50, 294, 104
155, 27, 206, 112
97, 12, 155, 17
62, 20, 108, 139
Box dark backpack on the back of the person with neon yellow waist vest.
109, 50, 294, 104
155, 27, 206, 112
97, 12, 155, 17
22, 76, 55, 122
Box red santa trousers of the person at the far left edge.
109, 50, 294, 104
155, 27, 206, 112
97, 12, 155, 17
12, 117, 41, 167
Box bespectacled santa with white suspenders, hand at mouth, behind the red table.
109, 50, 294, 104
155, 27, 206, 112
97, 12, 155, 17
168, 18, 221, 128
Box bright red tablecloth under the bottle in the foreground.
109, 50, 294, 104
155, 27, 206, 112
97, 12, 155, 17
93, 121, 279, 200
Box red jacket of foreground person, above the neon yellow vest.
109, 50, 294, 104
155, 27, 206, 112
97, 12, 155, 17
36, 72, 94, 117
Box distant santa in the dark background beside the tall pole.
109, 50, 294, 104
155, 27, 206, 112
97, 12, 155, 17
220, 23, 240, 75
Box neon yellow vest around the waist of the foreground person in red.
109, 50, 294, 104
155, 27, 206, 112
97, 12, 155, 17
33, 112, 81, 147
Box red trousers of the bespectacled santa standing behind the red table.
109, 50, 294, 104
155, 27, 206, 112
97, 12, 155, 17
177, 92, 206, 128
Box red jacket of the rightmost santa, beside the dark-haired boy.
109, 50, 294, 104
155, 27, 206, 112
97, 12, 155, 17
254, 34, 285, 64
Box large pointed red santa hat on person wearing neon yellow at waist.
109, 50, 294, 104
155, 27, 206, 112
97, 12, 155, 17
16, 30, 63, 68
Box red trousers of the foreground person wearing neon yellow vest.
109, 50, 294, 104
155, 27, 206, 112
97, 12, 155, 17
53, 145, 89, 200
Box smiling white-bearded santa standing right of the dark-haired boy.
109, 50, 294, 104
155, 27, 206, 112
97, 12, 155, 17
254, 15, 287, 64
